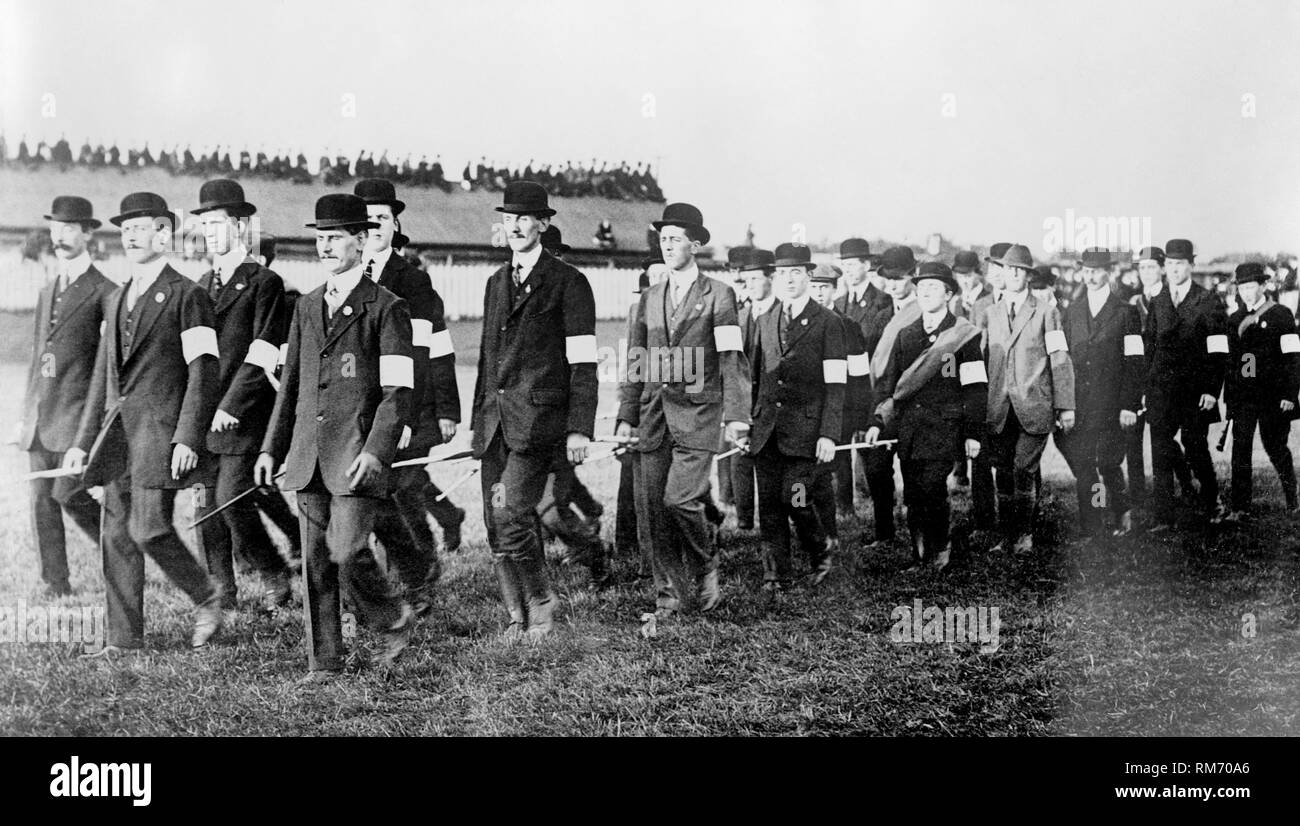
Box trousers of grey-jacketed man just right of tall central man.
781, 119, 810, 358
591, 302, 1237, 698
641, 432, 718, 610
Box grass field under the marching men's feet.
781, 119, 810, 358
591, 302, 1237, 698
0, 316, 1300, 735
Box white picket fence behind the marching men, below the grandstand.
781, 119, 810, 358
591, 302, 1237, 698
0, 251, 650, 321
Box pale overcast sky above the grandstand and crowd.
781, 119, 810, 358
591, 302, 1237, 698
0, 0, 1300, 254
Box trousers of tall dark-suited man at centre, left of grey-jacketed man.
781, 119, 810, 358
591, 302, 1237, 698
481, 431, 555, 620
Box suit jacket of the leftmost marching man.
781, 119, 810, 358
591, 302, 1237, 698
18, 265, 117, 453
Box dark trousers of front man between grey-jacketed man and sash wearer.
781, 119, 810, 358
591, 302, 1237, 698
754, 437, 835, 584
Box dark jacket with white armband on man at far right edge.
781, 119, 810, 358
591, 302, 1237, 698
1225, 304, 1300, 419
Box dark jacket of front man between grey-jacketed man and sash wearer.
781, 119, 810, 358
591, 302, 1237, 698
750, 299, 852, 458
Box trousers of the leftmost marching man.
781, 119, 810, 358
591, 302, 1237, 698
27, 445, 99, 592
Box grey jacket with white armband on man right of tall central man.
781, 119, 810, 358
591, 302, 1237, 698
619, 272, 766, 453
